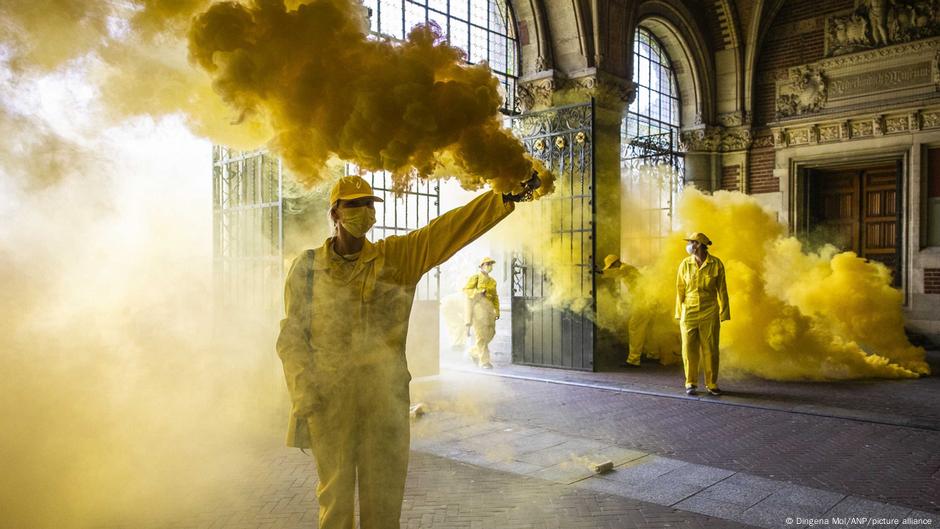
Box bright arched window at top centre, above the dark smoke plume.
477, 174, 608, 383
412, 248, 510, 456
363, 0, 519, 109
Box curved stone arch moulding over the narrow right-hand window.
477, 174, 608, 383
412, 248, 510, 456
630, 0, 716, 129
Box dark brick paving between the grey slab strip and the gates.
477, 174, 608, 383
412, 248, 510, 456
416, 358, 940, 513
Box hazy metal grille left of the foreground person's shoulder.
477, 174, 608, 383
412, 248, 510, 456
212, 146, 284, 311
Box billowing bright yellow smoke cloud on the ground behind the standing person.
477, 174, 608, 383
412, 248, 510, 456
628, 189, 929, 380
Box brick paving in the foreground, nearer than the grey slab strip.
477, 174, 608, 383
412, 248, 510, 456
117, 448, 760, 529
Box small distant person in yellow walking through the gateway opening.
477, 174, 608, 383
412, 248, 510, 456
463, 257, 499, 369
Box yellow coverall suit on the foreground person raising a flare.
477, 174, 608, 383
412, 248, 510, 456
277, 192, 514, 529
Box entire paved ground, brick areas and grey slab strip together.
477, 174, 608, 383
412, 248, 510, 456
108, 354, 940, 529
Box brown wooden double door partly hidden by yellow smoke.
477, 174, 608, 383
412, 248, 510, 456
808, 162, 902, 286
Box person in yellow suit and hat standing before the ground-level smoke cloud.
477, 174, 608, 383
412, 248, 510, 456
676, 233, 731, 396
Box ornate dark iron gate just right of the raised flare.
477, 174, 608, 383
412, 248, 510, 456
512, 101, 596, 371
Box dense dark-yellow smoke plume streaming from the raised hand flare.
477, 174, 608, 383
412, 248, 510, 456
189, 0, 551, 193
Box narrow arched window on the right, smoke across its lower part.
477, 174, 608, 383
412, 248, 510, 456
621, 27, 685, 263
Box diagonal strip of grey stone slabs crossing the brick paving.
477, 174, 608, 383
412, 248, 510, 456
412, 404, 940, 528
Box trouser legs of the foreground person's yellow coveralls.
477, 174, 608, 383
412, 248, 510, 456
308, 377, 411, 529
